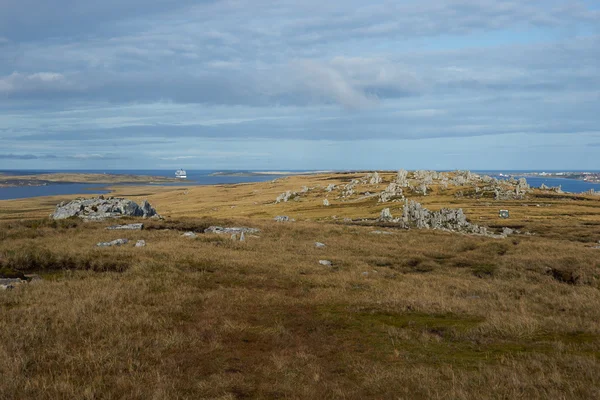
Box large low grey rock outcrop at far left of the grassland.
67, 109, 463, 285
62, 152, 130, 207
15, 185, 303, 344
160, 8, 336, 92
50, 196, 160, 220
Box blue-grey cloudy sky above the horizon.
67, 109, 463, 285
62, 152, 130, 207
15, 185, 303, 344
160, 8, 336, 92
0, 0, 600, 170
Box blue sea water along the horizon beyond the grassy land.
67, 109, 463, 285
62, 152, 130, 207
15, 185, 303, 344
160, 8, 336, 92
0, 170, 600, 200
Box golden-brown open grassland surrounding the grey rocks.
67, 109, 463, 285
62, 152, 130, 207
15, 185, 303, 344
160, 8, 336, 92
0, 174, 600, 399
